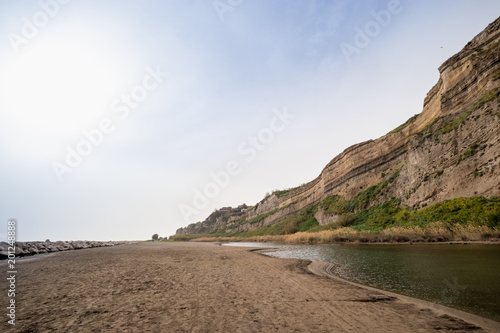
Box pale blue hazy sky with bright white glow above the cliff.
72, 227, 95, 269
0, 0, 500, 241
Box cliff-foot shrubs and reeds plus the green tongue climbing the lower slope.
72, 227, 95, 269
171, 169, 500, 242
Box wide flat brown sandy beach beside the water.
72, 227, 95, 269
0, 242, 500, 333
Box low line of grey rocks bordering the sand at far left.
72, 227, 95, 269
0, 239, 137, 259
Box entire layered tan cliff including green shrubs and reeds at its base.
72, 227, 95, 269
172, 19, 500, 242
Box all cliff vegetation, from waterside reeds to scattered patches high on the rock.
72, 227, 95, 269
171, 82, 500, 242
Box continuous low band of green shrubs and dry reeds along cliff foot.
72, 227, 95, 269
170, 197, 500, 243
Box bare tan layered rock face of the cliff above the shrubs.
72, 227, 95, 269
177, 19, 500, 234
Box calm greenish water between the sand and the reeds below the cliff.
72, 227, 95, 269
225, 243, 500, 321
